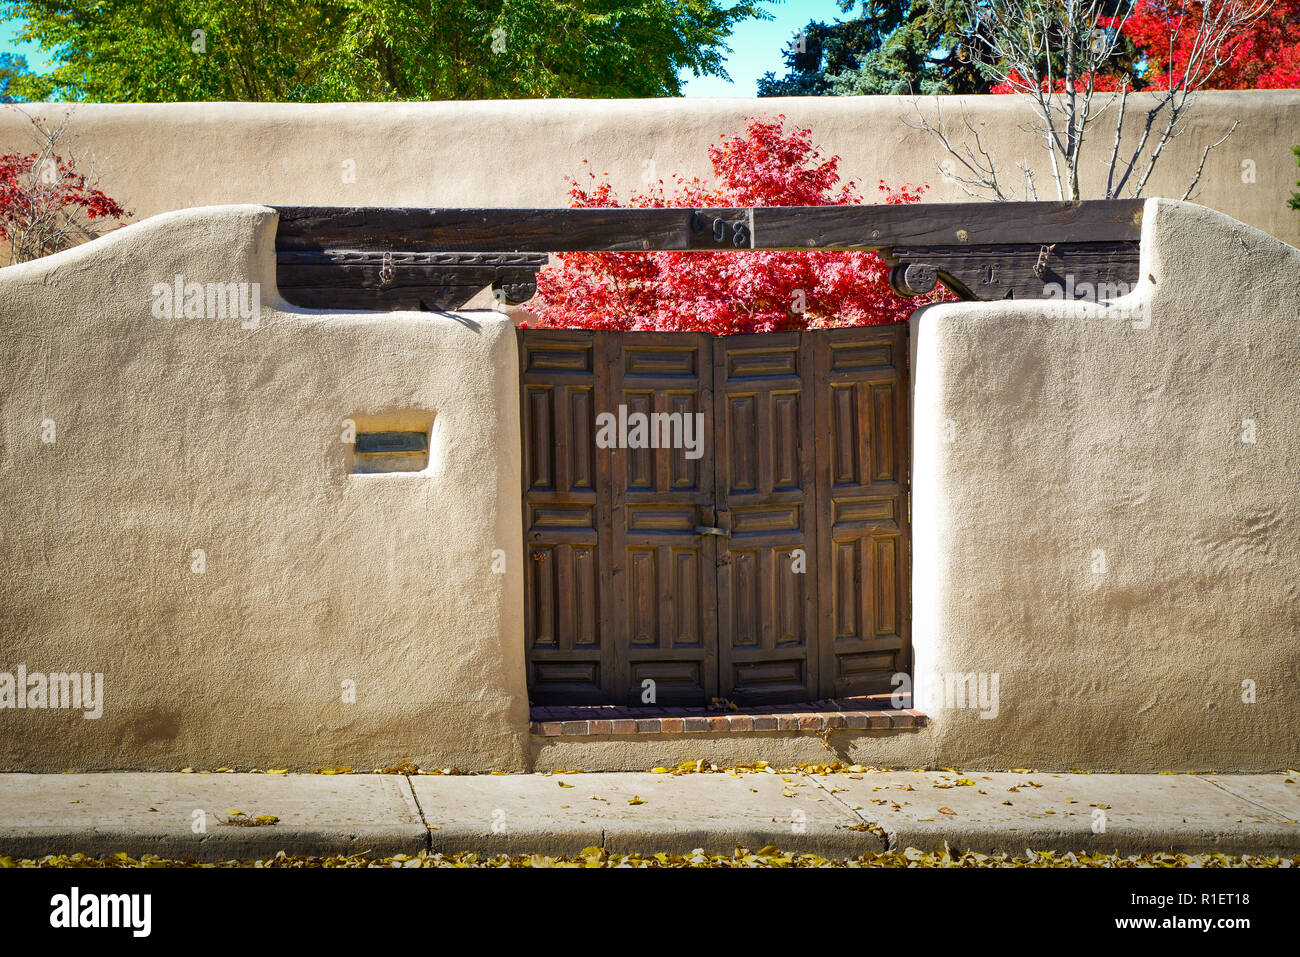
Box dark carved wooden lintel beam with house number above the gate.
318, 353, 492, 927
276, 200, 1143, 309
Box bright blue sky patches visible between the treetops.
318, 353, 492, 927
0, 0, 842, 96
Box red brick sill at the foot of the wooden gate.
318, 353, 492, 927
528, 694, 928, 737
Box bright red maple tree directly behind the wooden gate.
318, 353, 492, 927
529, 114, 941, 335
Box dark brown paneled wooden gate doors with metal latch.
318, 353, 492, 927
520, 326, 910, 705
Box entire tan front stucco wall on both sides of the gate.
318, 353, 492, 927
0, 200, 1300, 771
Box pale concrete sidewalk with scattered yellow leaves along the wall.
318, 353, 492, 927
0, 771, 1300, 861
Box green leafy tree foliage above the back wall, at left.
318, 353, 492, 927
0, 0, 770, 101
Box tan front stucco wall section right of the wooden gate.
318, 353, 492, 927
913, 200, 1300, 771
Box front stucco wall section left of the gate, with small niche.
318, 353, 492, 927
0, 207, 528, 771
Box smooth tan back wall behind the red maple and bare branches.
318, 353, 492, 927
0, 90, 1300, 244
